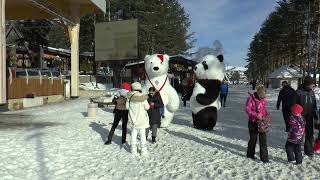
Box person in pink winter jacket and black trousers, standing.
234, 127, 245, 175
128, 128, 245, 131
246, 85, 269, 163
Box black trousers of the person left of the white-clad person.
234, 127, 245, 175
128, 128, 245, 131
108, 110, 129, 143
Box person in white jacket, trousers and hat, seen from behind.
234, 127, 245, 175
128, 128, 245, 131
126, 82, 150, 155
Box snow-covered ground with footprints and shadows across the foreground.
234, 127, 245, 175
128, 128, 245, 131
0, 87, 320, 180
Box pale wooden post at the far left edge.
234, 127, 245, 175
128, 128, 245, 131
0, 0, 7, 104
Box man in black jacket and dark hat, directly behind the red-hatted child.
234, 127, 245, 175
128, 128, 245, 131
296, 76, 318, 156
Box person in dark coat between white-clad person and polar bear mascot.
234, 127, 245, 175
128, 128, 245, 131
146, 87, 163, 143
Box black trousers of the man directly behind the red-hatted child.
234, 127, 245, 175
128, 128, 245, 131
304, 114, 314, 156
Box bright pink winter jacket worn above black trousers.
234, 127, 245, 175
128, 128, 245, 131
246, 93, 268, 122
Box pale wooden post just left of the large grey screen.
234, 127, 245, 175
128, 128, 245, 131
68, 22, 80, 98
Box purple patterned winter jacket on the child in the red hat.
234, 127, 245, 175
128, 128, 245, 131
288, 114, 306, 144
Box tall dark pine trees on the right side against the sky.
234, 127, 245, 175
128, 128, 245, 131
247, 0, 319, 82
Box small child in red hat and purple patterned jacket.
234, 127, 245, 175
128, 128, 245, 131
285, 104, 305, 164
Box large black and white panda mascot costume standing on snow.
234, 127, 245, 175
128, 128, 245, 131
190, 48, 225, 130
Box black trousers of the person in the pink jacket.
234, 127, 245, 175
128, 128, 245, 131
247, 121, 269, 162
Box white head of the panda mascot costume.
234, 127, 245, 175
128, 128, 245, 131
194, 55, 225, 81
